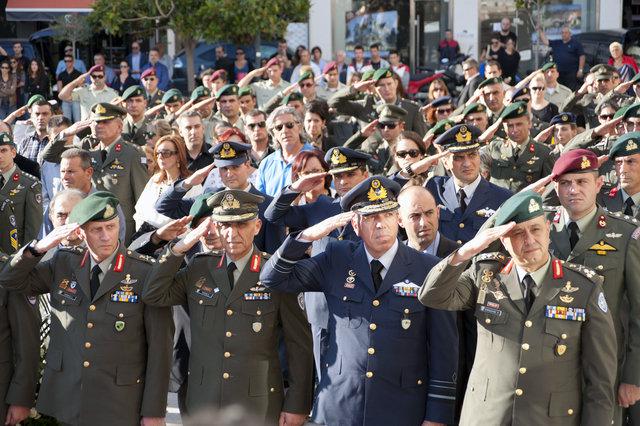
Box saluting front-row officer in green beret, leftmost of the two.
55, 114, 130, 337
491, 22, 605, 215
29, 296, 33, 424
0, 192, 173, 425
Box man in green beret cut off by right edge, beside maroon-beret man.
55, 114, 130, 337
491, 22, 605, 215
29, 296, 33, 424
598, 132, 640, 219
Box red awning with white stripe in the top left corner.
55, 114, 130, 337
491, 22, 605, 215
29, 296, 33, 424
6, 0, 93, 21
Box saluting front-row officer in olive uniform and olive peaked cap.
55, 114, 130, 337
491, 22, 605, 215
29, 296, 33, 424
143, 190, 313, 425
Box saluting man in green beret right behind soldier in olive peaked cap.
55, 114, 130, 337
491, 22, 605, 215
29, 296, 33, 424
328, 68, 427, 136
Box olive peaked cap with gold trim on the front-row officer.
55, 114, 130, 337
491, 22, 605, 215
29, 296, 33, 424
207, 189, 264, 222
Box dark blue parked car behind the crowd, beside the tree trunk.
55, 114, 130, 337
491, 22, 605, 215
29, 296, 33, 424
173, 42, 288, 94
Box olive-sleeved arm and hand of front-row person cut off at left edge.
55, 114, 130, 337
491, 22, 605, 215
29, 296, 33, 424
0, 253, 40, 426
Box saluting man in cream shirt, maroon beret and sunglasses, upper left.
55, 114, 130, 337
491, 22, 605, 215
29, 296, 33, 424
58, 65, 118, 121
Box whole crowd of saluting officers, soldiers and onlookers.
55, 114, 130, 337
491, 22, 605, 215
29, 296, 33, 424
0, 22, 640, 426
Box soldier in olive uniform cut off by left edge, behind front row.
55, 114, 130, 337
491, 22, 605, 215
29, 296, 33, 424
0, 132, 42, 253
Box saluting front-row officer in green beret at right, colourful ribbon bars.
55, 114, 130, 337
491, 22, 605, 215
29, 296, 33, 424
419, 191, 616, 426
